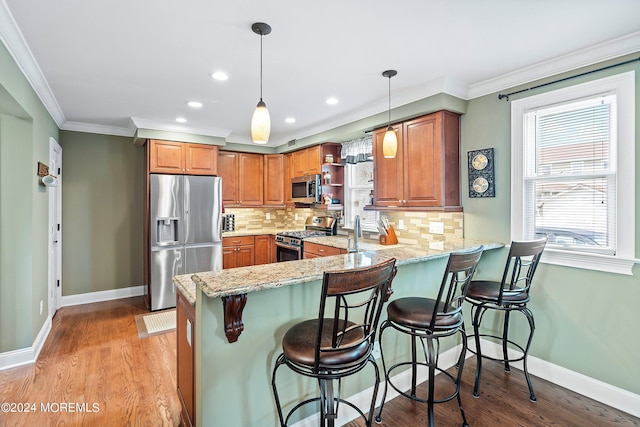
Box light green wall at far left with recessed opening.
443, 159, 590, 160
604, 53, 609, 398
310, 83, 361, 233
0, 44, 58, 352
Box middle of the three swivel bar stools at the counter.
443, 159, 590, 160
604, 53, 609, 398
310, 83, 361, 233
376, 246, 483, 426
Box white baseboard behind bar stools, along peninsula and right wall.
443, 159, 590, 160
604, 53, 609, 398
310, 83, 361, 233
292, 340, 640, 427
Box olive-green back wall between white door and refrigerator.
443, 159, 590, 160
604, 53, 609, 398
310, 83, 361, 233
60, 131, 145, 295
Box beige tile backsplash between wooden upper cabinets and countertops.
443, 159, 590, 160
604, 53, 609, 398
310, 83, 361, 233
226, 208, 464, 244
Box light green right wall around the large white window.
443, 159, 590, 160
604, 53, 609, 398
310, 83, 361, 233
462, 54, 640, 393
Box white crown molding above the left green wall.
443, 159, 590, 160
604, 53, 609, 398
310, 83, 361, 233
0, 0, 65, 127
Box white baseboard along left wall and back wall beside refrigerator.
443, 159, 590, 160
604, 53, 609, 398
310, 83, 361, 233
0, 285, 144, 371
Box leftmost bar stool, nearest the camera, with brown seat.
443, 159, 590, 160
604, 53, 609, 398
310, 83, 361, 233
271, 258, 396, 427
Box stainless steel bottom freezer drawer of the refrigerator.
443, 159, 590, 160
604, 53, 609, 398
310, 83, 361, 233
150, 247, 185, 310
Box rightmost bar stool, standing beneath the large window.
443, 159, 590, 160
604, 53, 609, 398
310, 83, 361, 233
466, 237, 547, 402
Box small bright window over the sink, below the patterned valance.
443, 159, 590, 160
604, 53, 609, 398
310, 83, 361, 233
344, 162, 378, 231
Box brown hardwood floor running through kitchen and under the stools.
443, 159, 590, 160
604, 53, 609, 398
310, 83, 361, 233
0, 297, 640, 427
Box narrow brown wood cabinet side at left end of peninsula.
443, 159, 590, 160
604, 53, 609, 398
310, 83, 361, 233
176, 290, 196, 426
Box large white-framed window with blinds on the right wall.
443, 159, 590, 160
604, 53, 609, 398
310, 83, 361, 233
511, 72, 635, 274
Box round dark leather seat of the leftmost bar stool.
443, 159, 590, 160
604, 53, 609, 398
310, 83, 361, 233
282, 319, 369, 368
